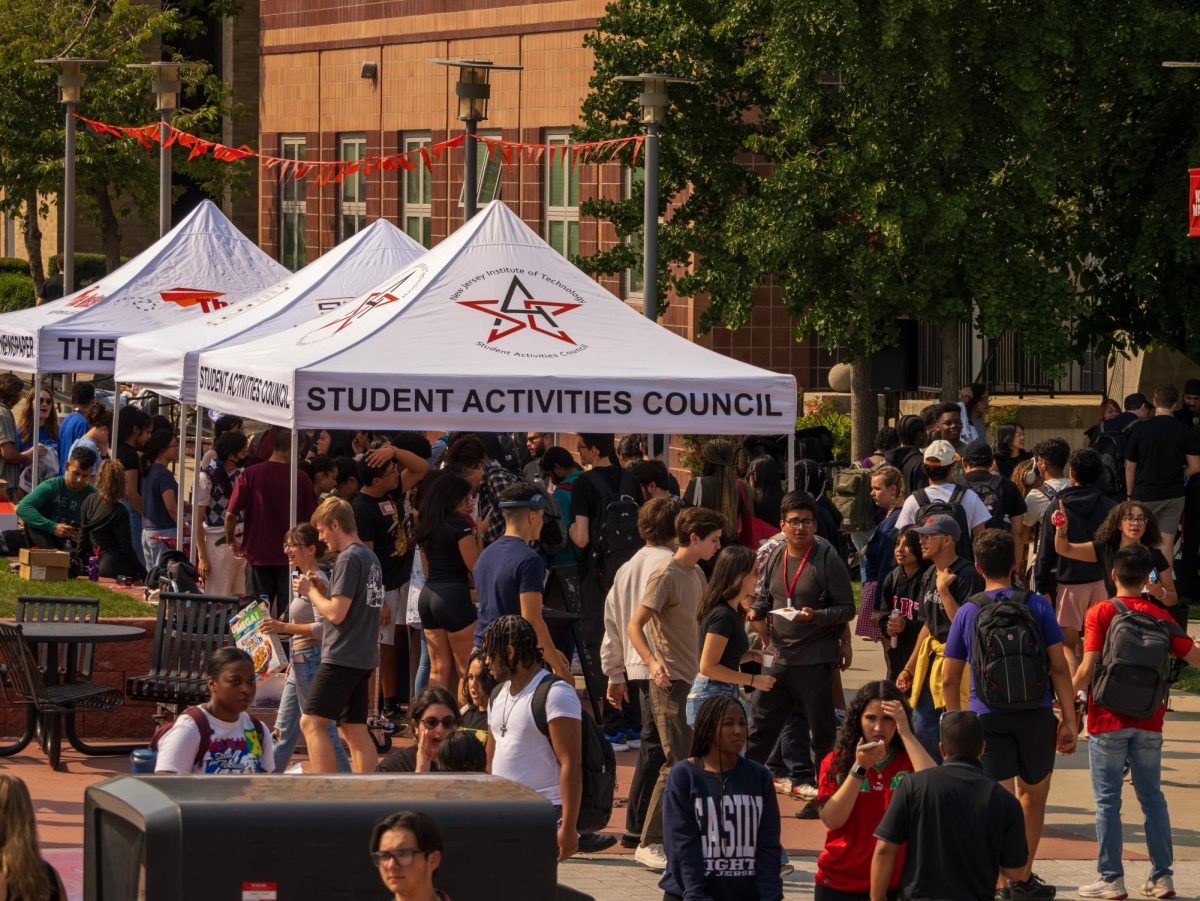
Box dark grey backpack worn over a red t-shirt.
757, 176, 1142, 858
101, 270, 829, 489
1092, 597, 1187, 720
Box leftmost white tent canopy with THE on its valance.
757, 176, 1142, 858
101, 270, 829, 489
0, 200, 288, 376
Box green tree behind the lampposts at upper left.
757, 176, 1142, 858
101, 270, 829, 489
0, 0, 245, 289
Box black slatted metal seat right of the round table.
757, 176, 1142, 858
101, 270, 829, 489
125, 591, 248, 720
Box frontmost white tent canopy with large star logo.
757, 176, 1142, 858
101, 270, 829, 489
197, 202, 796, 434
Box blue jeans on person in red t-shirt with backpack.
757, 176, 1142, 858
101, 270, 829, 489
1087, 729, 1175, 881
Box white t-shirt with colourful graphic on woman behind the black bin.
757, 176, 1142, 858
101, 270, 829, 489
154, 708, 275, 776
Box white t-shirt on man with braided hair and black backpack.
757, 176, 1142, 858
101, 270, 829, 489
487, 669, 583, 804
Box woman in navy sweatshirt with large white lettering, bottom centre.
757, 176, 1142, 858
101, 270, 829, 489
659, 695, 784, 901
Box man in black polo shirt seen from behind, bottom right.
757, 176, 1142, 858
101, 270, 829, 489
871, 710, 1028, 901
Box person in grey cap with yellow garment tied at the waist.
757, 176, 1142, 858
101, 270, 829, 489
896, 513, 983, 761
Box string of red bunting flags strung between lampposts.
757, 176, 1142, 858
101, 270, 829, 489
76, 114, 644, 185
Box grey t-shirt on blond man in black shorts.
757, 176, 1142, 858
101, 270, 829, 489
320, 542, 384, 669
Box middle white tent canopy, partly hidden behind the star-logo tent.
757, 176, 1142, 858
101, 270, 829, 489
115, 220, 425, 403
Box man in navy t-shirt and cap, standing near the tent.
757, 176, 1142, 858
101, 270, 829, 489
472, 483, 571, 679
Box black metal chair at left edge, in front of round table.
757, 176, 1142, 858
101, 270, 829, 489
0, 623, 125, 769
